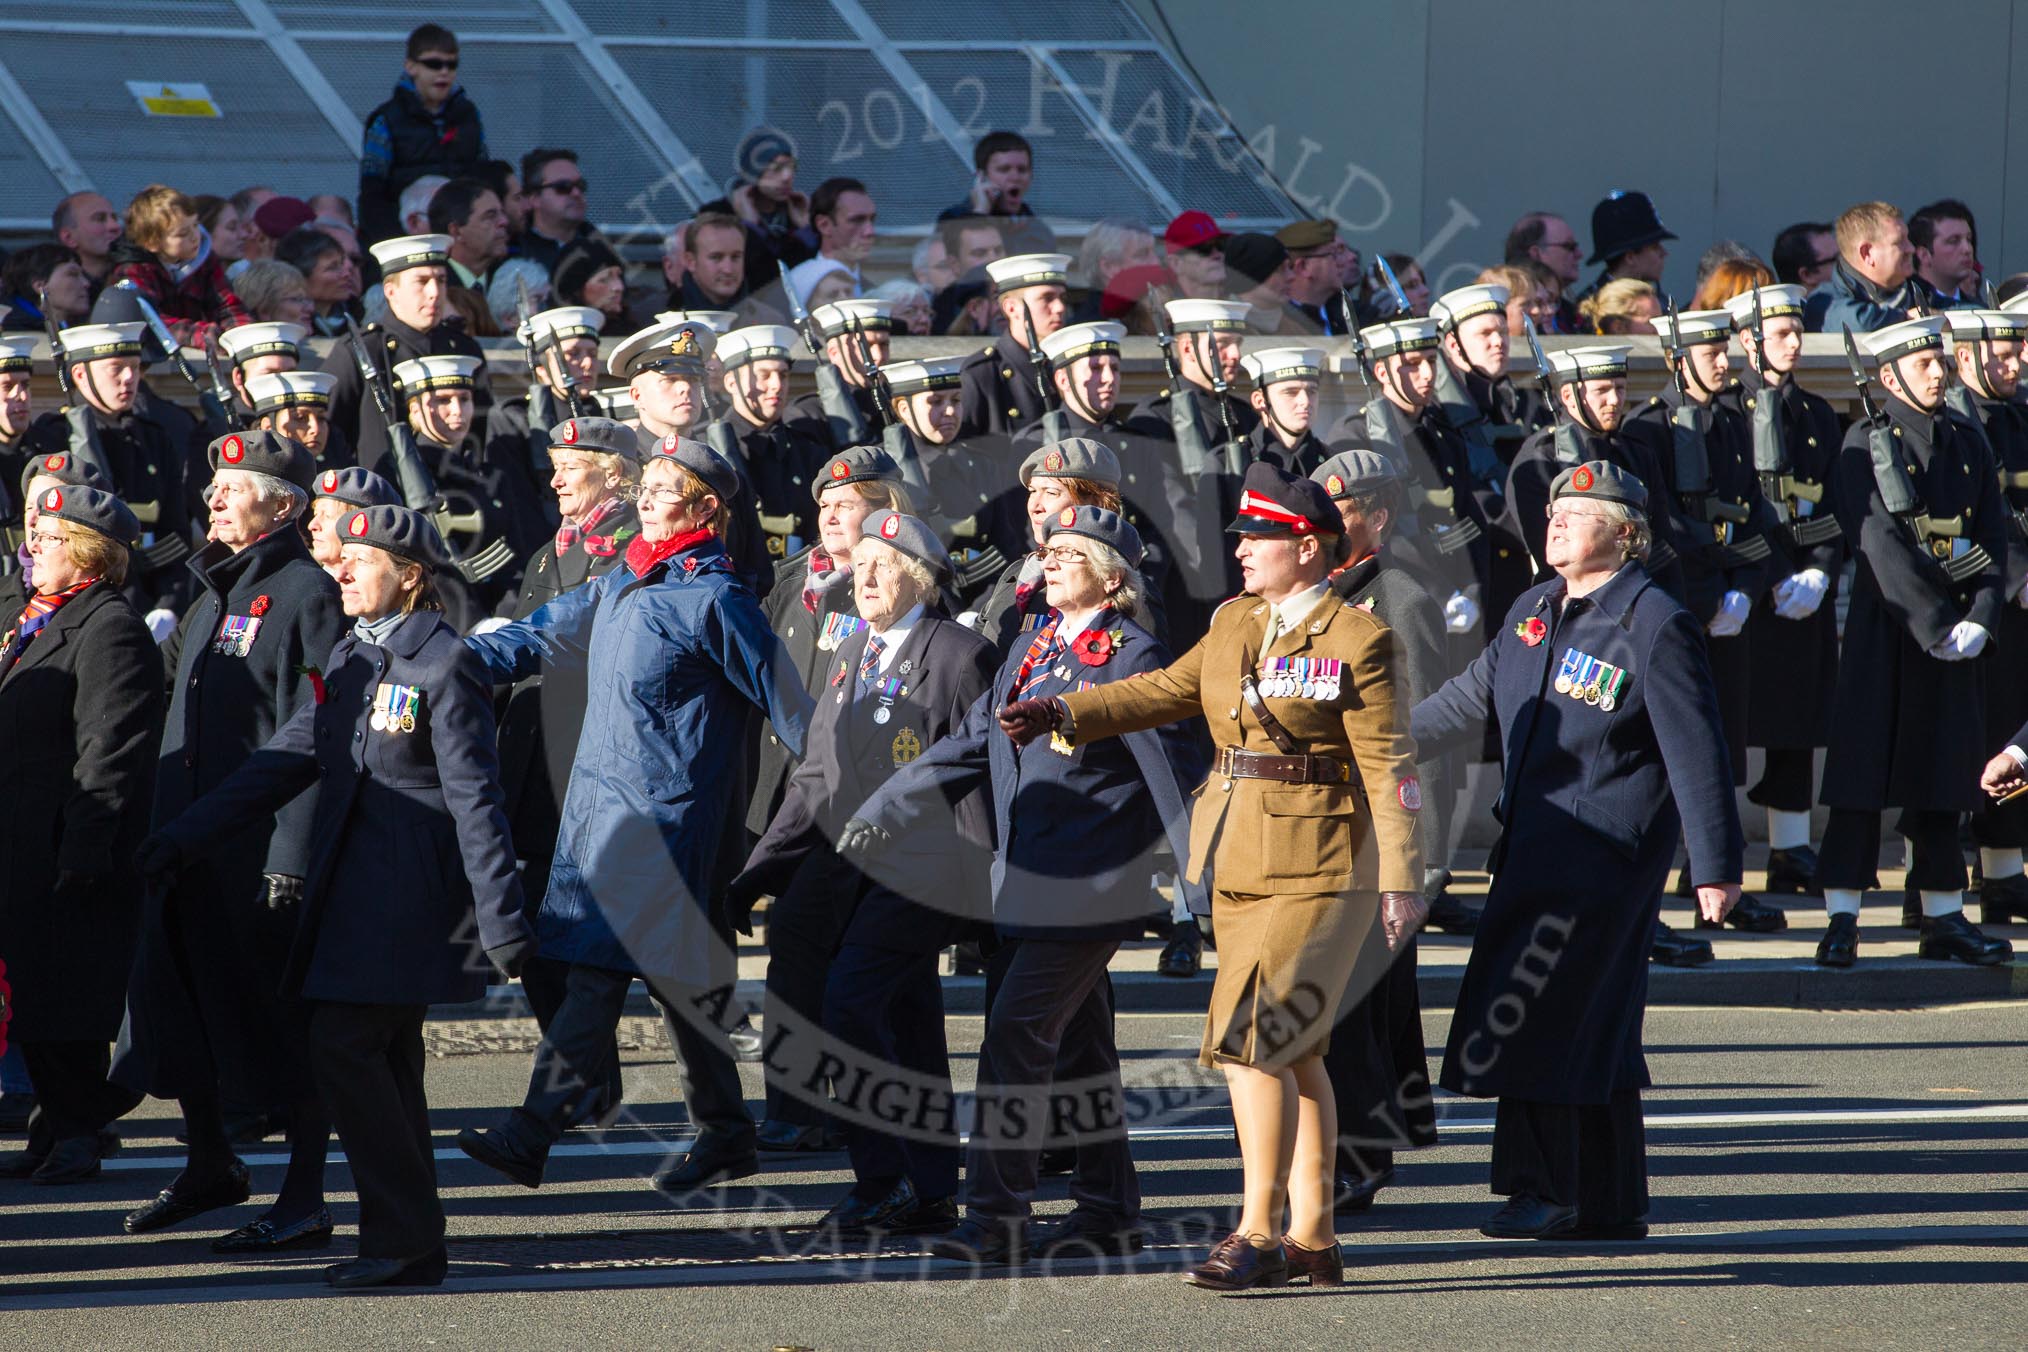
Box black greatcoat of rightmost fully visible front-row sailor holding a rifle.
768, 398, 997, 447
1821, 395, 2006, 813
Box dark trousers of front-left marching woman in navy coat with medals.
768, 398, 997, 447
310, 1001, 444, 1259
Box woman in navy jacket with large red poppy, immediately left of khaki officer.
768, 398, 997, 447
848, 505, 1203, 1263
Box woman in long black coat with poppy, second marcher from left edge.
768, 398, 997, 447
114, 432, 345, 1253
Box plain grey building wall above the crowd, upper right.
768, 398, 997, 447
1130, 0, 2028, 302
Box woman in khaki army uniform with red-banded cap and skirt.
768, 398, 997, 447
1000, 462, 1426, 1291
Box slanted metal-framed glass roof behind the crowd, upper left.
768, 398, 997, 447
0, 0, 1300, 237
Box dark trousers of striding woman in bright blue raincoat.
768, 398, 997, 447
517, 965, 754, 1149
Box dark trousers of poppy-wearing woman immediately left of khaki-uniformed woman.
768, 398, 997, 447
965, 938, 1140, 1226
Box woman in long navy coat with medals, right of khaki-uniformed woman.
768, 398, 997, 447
1409, 460, 1742, 1238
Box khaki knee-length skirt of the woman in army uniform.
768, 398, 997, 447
1197, 890, 1387, 1070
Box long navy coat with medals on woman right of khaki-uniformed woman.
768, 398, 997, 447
1409, 561, 1744, 1103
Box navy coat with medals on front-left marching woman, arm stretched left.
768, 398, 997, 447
162, 610, 529, 1005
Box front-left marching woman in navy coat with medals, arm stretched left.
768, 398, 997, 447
140, 507, 533, 1289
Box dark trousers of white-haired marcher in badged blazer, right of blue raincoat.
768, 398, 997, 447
823, 943, 957, 1200
